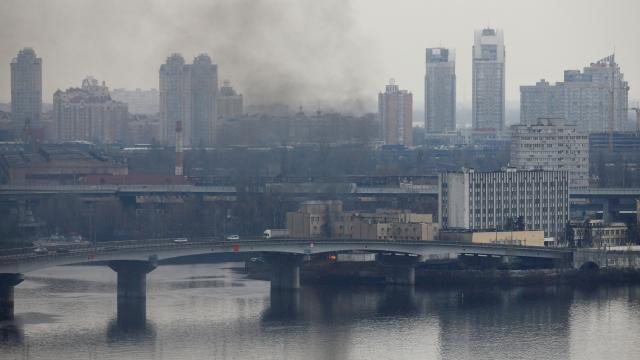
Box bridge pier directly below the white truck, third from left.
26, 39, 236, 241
263, 253, 303, 293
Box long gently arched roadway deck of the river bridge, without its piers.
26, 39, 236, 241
0, 239, 571, 273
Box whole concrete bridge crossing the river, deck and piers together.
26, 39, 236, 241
0, 239, 571, 320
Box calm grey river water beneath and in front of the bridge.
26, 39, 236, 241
0, 264, 640, 360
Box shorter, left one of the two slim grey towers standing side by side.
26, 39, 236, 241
424, 48, 456, 134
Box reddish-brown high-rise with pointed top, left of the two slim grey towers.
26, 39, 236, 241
378, 79, 413, 146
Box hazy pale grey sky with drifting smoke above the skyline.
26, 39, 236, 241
0, 0, 640, 110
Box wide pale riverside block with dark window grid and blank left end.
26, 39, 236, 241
438, 169, 569, 238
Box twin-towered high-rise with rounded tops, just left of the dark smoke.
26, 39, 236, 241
159, 54, 218, 146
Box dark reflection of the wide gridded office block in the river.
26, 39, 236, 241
435, 287, 573, 359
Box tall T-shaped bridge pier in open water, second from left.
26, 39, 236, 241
109, 260, 156, 326
